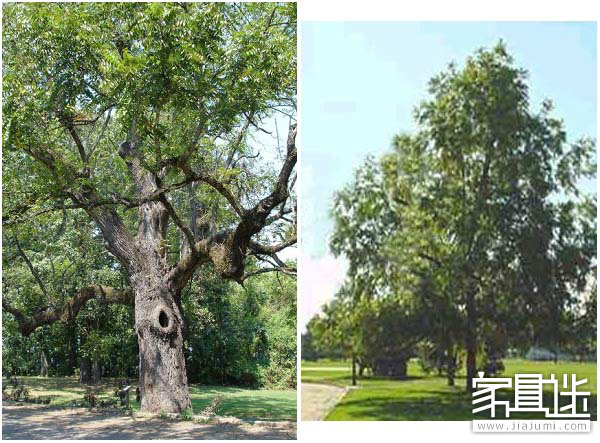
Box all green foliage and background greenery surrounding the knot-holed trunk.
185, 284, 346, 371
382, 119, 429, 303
2, 2, 296, 396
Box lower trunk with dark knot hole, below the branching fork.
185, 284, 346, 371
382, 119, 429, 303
132, 270, 191, 413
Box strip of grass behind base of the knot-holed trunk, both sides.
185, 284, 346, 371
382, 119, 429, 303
2, 377, 296, 421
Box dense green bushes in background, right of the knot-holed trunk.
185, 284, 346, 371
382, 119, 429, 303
184, 266, 296, 388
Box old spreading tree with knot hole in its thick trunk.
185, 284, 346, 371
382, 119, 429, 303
2, 3, 297, 412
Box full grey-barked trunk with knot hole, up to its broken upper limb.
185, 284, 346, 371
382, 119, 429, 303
115, 134, 193, 413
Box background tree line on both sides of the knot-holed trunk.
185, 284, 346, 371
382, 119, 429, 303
2, 264, 296, 388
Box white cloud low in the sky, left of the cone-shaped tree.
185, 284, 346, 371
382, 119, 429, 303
298, 252, 348, 332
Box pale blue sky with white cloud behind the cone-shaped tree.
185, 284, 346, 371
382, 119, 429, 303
300, 22, 596, 326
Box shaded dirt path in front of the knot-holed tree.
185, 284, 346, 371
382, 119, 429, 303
2, 404, 296, 440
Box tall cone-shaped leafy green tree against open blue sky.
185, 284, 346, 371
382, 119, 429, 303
332, 44, 596, 389
